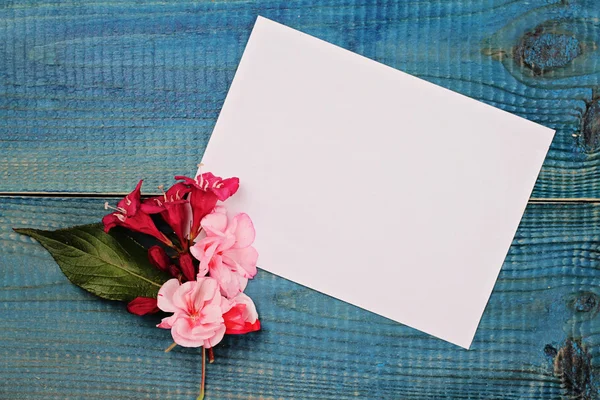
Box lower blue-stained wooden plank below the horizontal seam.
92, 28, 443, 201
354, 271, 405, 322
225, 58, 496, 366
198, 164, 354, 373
0, 197, 600, 400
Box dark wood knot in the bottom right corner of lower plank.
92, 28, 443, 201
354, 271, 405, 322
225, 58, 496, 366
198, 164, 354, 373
554, 339, 598, 400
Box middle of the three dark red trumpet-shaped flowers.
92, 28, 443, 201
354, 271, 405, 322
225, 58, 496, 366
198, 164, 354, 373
142, 182, 192, 250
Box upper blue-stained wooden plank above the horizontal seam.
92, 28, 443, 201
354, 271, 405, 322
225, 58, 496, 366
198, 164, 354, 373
0, 0, 600, 198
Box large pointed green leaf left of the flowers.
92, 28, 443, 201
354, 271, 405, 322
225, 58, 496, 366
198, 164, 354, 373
15, 224, 170, 301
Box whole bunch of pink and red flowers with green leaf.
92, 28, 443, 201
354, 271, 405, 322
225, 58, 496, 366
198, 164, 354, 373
15, 172, 260, 399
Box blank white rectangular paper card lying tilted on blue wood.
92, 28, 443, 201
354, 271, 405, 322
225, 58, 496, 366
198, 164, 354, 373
202, 17, 554, 348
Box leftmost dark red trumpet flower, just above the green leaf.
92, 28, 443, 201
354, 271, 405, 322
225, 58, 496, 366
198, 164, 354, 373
102, 181, 173, 246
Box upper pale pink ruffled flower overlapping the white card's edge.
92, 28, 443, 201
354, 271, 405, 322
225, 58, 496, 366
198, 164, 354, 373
190, 207, 258, 298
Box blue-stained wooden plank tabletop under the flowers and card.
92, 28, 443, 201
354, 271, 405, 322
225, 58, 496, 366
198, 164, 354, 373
0, 0, 600, 400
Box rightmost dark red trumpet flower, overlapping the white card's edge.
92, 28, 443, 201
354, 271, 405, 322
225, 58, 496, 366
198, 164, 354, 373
175, 172, 240, 240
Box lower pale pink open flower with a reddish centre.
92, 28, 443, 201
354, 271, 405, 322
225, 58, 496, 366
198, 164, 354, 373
157, 277, 226, 349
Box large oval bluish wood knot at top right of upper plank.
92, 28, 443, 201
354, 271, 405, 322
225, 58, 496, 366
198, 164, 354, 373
513, 28, 582, 76
